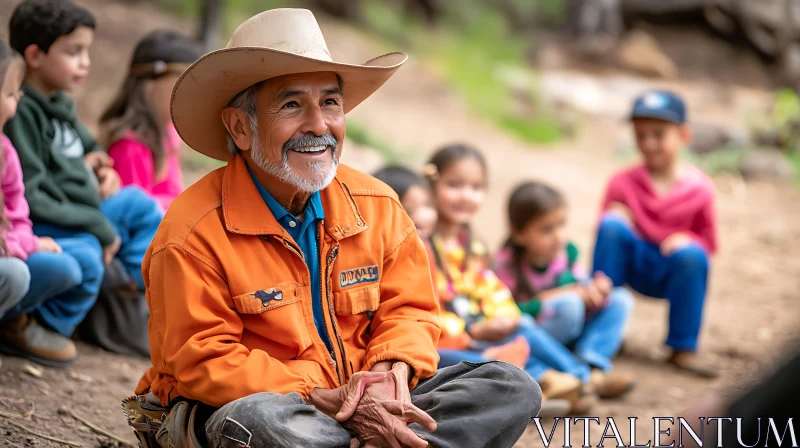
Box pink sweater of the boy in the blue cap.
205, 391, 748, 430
602, 165, 717, 254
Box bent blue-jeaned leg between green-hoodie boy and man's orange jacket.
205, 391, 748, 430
100, 186, 164, 291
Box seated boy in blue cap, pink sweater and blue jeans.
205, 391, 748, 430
594, 91, 717, 377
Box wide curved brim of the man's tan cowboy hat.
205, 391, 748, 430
170, 47, 408, 161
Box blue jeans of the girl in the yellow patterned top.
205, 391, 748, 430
439, 315, 590, 382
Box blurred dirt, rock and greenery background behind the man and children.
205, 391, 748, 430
0, 0, 800, 447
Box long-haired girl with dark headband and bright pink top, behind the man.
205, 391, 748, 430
100, 31, 202, 210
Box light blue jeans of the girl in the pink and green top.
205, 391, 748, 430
538, 288, 633, 371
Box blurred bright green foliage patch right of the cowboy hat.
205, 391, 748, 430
364, 0, 562, 143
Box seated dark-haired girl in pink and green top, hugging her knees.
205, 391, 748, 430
494, 182, 633, 398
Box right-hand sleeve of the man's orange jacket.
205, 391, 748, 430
364, 226, 440, 388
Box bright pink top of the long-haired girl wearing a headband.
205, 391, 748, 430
108, 125, 183, 210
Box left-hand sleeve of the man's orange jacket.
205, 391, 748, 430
144, 244, 324, 407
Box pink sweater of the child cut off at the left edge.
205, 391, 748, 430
0, 133, 39, 260
